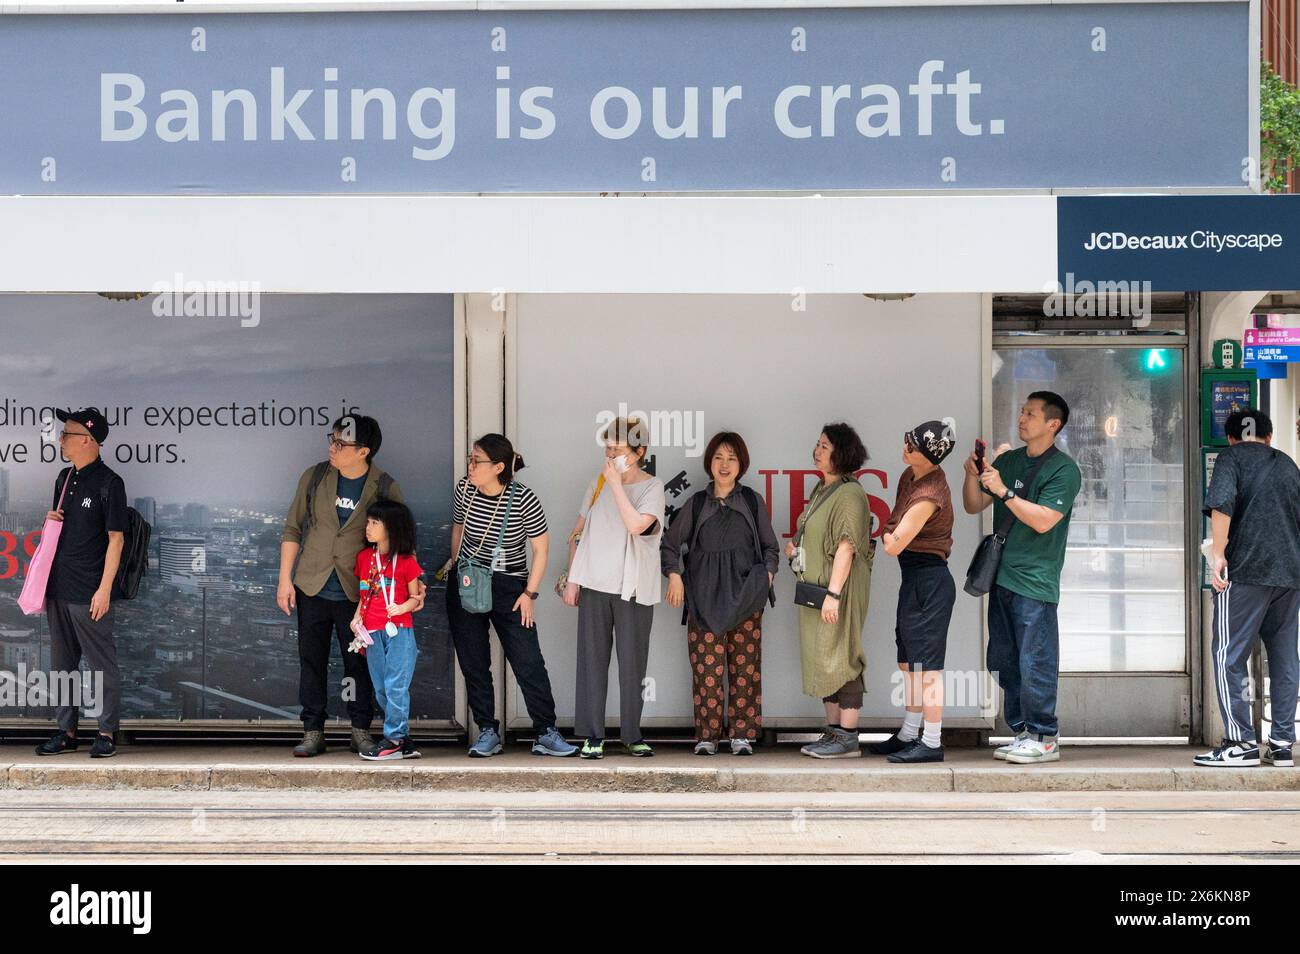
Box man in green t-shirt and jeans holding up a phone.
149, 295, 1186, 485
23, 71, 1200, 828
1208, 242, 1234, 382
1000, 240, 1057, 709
962, 391, 1082, 764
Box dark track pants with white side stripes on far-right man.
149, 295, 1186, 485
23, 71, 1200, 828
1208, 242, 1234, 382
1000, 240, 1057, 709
1213, 584, 1300, 742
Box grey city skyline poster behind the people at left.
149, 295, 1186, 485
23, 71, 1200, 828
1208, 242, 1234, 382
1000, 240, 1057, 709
0, 294, 454, 720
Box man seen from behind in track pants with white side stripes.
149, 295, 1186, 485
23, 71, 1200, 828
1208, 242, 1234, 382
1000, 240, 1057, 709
1193, 411, 1300, 767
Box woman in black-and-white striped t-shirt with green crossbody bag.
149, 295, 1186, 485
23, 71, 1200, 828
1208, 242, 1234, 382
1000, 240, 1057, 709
443, 434, 577, 758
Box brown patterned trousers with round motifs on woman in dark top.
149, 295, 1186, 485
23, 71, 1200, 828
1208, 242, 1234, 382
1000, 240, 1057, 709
686, 610, 763, 741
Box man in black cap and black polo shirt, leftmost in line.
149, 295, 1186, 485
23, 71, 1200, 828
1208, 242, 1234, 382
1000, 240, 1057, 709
36, 407, 127, 759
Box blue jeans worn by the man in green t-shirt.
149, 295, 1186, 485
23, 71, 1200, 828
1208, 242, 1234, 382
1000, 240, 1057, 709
988, 586, 1061, 738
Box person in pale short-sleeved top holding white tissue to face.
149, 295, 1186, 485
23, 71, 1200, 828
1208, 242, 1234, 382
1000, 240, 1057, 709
564, 417, 664, 759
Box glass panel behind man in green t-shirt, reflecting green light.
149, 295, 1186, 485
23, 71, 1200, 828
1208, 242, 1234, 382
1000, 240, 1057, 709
991, 347, 1187, 672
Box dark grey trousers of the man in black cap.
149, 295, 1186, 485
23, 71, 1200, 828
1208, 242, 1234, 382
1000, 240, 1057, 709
46, 599, 121, 734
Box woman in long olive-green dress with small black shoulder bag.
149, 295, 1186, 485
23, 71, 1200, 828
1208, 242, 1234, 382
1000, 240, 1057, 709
785, 424, 875, 759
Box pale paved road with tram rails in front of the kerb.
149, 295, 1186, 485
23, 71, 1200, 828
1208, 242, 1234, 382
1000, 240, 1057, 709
0, 790, 1300, 864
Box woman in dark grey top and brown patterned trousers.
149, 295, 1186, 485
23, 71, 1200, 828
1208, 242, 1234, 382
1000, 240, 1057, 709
659, 432, 780, 755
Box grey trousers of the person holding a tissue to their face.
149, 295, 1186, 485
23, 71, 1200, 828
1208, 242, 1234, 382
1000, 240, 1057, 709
573, 587, 654, 743
